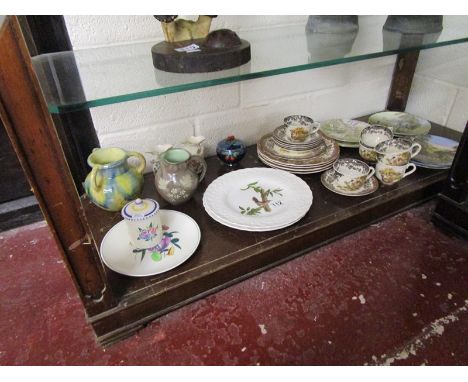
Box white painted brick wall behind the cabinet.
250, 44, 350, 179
65, 16, 468, 172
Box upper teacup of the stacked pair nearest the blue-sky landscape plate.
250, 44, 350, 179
375, 138, 421, 166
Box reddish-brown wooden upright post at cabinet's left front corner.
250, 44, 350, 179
0, 16, 106, 299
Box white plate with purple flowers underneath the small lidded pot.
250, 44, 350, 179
100, 210, 201, 277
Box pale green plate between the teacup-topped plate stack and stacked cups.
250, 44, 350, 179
320, 119, 369, 148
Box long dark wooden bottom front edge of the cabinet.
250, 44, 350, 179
89, 173, 447, 346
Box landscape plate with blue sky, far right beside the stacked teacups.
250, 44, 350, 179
412, 134, 458, 170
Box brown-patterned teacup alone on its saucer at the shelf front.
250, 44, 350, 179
333, 158, 375, 191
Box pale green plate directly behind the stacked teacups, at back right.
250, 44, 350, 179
369, 111, 431, 136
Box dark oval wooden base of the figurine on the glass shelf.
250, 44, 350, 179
151, 39, 250, 73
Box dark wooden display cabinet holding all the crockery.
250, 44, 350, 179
0, 17, 468, 345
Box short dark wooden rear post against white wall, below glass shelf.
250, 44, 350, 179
386, 50, 419, 111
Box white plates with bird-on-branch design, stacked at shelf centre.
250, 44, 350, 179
203, 167, 312, 231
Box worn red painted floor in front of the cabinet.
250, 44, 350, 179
0, 203, 468, 365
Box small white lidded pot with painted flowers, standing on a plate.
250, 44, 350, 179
121, 199, 162, 249
